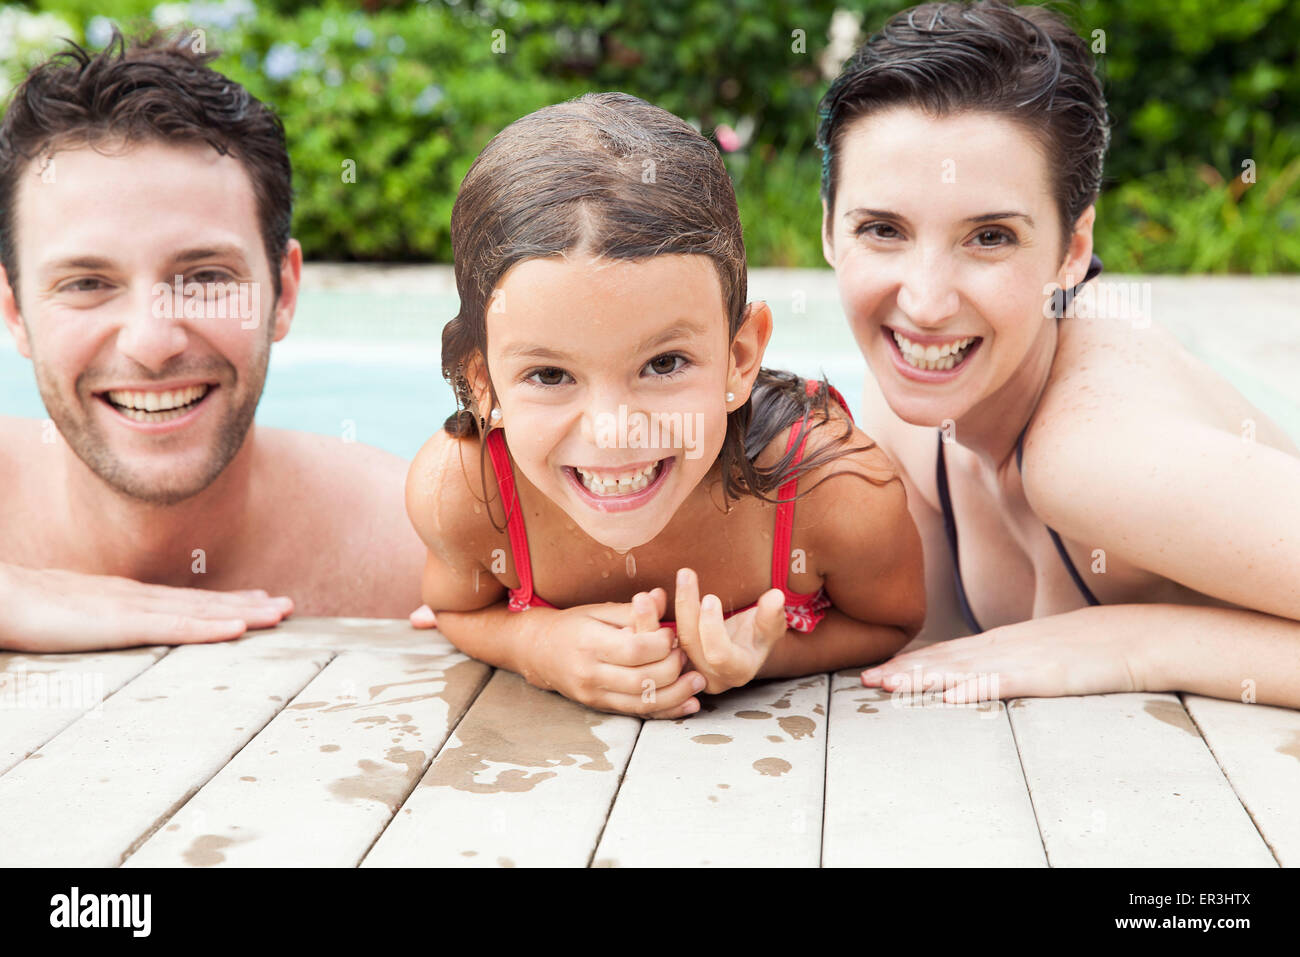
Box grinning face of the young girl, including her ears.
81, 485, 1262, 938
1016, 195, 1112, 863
478, 254, 771, 551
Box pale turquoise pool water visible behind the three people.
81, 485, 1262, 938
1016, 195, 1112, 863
0, 267, 1300, 459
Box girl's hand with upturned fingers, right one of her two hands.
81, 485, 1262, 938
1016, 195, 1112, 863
676, 568, 785, 694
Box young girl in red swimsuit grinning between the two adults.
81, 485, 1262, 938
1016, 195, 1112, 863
407, 94, 926, 718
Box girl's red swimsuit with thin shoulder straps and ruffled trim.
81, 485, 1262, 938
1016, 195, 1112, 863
488, 380, 853, 632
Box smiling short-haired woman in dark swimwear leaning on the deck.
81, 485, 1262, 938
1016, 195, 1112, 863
819, 3, 1300, 706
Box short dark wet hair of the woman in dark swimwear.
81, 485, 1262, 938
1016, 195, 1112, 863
818, 0, 1110, 256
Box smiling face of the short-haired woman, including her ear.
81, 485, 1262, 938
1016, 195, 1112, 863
823, 108, 1093, 426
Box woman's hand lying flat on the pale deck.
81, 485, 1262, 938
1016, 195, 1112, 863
862, 607, 1145, 703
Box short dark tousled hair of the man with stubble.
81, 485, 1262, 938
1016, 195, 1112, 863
0, 27, 293, 298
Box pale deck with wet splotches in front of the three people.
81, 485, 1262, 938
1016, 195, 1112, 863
0, 619, 1300, 867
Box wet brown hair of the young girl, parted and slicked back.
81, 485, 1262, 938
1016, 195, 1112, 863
442, 92, 889, 530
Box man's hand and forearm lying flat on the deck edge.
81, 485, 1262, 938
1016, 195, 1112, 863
0, 564, 294, 654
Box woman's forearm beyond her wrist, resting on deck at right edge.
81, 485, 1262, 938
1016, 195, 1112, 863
1133, 605, 1300, 707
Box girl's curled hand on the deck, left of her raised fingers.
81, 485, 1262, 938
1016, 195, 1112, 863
521, 588, 705, 718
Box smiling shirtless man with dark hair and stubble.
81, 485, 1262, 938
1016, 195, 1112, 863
0, 29, 424, 650
